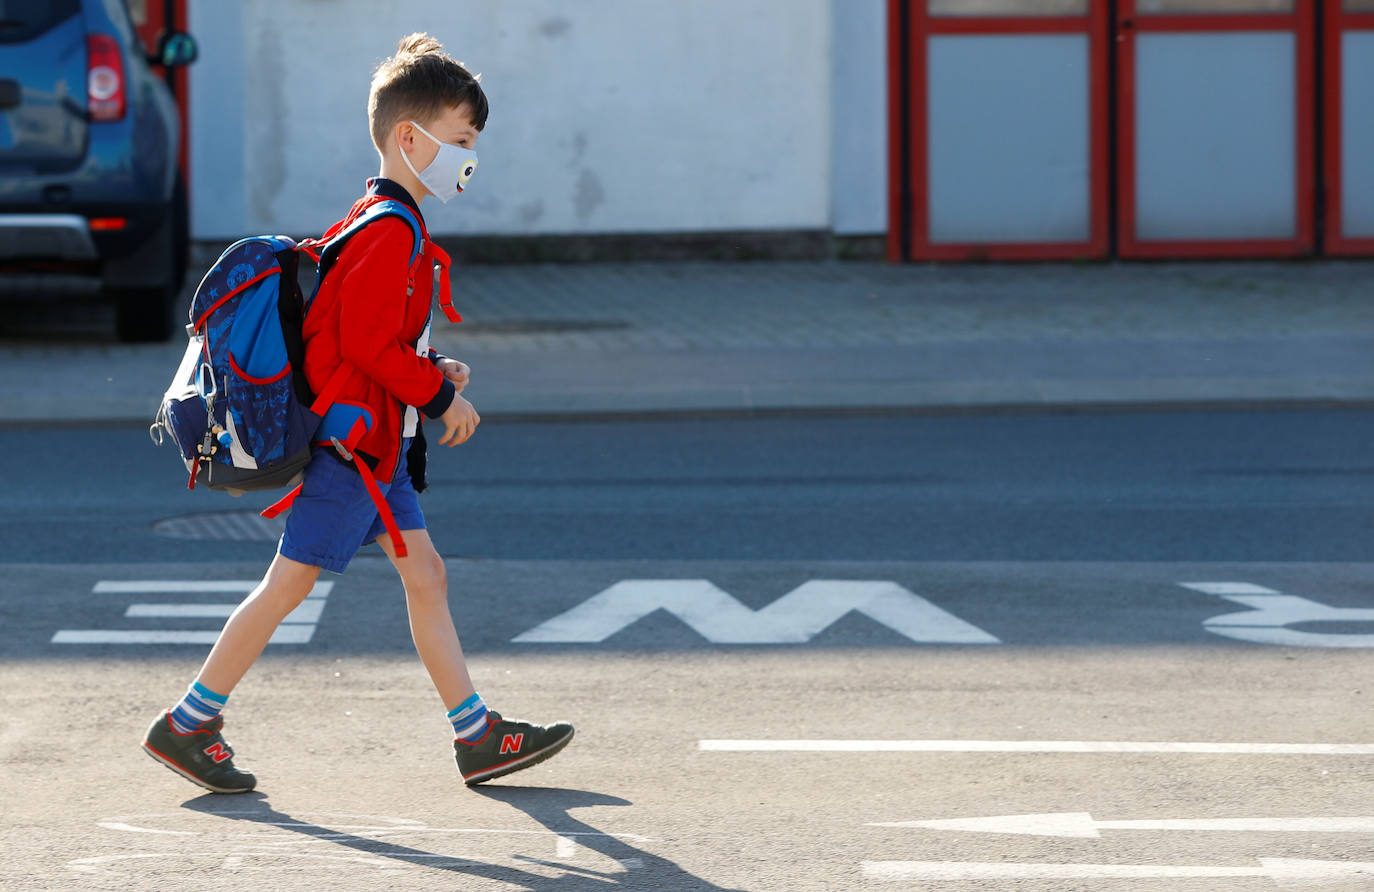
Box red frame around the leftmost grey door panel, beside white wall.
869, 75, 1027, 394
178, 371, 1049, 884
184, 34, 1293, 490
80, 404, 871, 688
888, 0, 1110, 260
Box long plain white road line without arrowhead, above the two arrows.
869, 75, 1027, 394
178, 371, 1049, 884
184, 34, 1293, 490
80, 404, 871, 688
697, 739, 1374, 756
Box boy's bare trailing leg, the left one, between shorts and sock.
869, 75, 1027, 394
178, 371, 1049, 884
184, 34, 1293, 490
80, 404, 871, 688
196, 554, 320, 697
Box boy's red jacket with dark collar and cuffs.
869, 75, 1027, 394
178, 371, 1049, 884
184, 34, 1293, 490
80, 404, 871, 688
302, 177, 453, 482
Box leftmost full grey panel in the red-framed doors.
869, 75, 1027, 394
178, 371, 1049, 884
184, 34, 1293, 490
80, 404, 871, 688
927, 34, 1090, 243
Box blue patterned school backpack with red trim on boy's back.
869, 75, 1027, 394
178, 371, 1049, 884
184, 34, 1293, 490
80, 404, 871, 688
150, 199, 425, 541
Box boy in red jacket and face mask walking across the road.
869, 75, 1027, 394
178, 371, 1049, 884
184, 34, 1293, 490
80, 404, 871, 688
143, 34, 573, 793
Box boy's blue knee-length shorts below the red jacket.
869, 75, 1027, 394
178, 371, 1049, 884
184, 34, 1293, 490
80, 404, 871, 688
276, 440, 425, 573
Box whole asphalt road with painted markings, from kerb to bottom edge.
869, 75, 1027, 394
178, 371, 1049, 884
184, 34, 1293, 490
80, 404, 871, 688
0, 411, 1374, 892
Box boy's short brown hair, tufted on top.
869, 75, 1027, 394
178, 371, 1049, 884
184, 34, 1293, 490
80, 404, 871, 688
367, 33, 488, 151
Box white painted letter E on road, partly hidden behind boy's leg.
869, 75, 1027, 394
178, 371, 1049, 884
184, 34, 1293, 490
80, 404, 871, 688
49, 579, 334, 646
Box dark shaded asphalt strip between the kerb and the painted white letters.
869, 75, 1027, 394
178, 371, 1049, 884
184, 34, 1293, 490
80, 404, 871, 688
0, 410, 1374, 562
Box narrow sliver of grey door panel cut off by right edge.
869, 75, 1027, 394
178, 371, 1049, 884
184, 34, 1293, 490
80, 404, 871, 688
1341, 32, 1374, 238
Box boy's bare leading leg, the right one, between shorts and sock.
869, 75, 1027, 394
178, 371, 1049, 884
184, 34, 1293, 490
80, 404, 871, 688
376, 529, 475, 709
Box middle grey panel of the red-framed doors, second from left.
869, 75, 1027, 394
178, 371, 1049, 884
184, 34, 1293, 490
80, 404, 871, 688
1135, 33, 1297, 241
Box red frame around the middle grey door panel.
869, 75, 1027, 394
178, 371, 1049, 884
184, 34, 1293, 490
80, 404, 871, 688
1117, 0, 1316, 258
